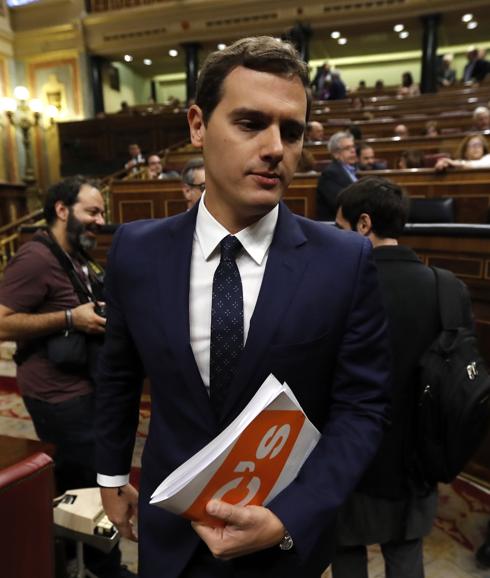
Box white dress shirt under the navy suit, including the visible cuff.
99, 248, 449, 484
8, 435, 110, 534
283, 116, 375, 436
97, 193, 279, 487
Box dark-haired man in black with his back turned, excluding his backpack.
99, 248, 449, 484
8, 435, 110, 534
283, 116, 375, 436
332, 177, 478, 578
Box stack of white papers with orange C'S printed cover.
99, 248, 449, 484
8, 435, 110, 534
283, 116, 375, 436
150, 374, 320, 525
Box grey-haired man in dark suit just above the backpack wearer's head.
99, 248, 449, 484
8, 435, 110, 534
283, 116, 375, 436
316, 131, 357, 221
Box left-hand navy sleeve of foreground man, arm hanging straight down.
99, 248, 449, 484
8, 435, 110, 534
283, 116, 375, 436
95, 226, 143, 476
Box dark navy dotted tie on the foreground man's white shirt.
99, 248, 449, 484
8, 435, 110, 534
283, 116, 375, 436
209, 235, 243, 414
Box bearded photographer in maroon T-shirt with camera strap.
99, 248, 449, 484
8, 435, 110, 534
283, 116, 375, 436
0, 176, 134, 578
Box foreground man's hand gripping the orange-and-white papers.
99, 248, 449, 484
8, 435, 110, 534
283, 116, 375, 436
192, 500, 285, 560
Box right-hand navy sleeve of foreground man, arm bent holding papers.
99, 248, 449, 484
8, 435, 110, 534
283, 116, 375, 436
268, 240, 391, 560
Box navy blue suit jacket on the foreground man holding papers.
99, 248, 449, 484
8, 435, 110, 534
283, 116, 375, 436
96, 204, 389, 578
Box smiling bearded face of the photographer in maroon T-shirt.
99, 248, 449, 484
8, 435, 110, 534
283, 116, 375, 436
66, 185, 105, 251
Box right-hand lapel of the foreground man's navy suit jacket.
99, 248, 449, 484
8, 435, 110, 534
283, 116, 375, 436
222, 203, 308, 418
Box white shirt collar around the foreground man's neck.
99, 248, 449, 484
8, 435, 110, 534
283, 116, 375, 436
195, 193, 279, 265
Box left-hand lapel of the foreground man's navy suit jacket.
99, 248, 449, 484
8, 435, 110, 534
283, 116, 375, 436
157, 204, 214, 426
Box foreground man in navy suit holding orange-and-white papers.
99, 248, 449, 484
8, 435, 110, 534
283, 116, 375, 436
96, 37, 389, 578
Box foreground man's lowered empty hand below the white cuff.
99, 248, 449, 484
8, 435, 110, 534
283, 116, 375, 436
100, 484, 138, 542
